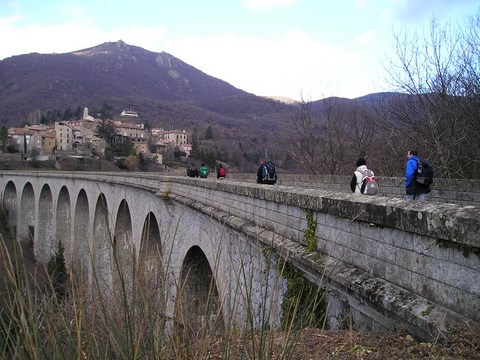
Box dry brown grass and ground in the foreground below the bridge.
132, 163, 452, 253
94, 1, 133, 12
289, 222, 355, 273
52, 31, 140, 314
0, 212, 480, 360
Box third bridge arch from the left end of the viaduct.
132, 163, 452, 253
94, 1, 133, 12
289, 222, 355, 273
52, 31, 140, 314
35, 184, 56, 263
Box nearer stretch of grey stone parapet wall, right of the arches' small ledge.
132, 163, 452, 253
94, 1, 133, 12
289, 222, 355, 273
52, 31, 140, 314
162, 178, 480, 337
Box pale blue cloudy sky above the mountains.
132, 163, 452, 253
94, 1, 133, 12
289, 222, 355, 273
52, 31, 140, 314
0, 0, 480, 101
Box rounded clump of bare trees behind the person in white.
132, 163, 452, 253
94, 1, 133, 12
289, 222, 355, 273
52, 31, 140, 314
286, 97, 378, 175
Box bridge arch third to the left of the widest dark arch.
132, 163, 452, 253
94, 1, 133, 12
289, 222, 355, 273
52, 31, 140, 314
92, 194, 113, 293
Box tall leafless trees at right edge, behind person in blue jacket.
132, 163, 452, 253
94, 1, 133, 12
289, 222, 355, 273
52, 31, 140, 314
382, 15, 480, 178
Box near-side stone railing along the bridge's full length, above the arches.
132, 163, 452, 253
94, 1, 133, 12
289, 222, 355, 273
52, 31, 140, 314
2, 173, 480, 338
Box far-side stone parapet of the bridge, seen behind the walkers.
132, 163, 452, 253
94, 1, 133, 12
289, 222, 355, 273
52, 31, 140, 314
228, 173, 480, 206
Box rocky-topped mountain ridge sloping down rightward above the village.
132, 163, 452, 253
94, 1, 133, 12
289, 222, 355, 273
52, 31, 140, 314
0, 41, 296, 123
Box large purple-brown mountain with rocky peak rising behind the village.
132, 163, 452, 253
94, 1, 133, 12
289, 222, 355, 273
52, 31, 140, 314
0, 41, 288, 132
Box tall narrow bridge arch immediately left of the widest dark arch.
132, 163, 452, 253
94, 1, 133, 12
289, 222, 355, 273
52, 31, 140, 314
138, 212, 166, 305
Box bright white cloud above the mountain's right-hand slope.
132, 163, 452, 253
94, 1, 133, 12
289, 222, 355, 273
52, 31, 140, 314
166, 31, 370, 99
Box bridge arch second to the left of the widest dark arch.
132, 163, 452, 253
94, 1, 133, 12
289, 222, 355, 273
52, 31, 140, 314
112, 199, 135, 296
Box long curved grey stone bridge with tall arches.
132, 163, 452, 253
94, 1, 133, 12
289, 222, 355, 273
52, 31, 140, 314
0, 171, 480, 339
